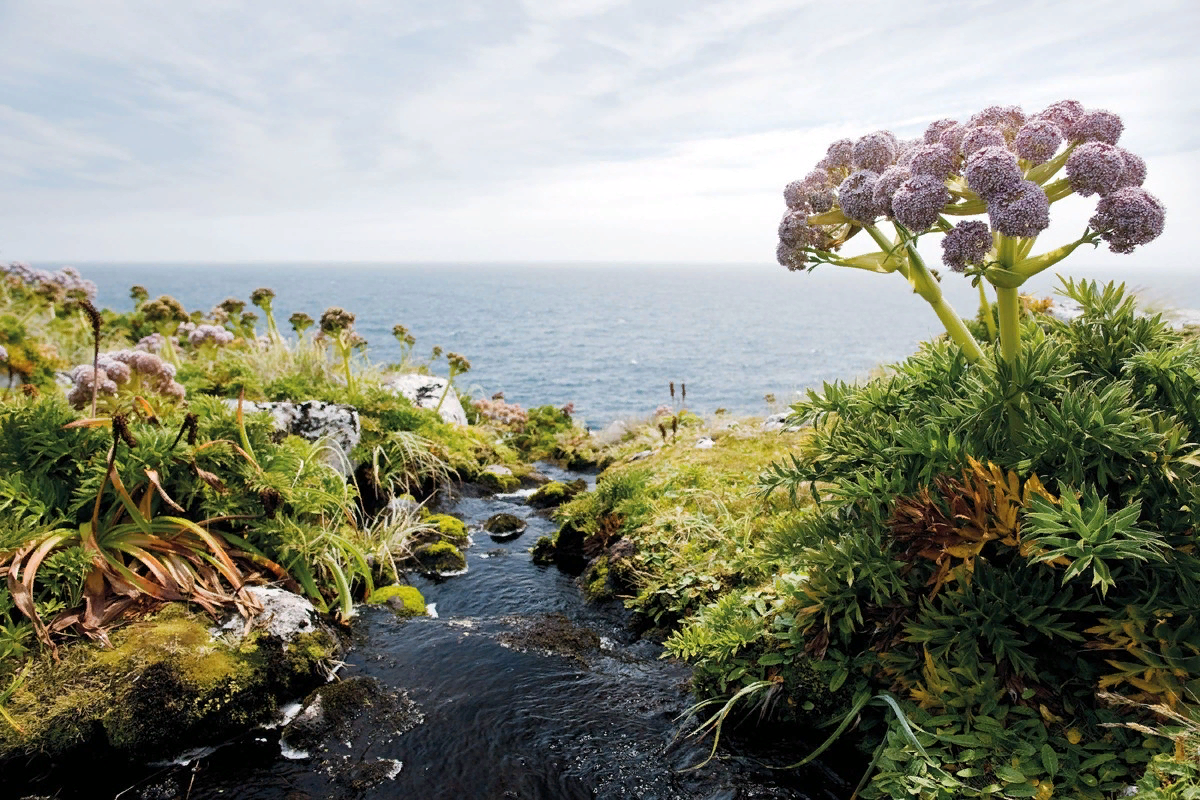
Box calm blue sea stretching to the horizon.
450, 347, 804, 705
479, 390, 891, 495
75, 264, 1200, 426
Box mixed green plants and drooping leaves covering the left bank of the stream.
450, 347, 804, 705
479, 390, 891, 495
0, 265, 597, 709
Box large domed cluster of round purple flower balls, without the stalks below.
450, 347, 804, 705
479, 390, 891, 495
776, 101, 1163, 270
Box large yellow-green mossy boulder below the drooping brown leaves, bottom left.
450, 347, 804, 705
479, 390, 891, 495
0, 604, 338, 763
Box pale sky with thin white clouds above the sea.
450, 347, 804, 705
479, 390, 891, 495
0, 0, 1200, 269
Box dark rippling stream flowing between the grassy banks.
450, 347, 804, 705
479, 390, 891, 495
18, 464, 848, 800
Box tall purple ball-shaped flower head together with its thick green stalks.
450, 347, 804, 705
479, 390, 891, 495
776, 100, 1165, 363
